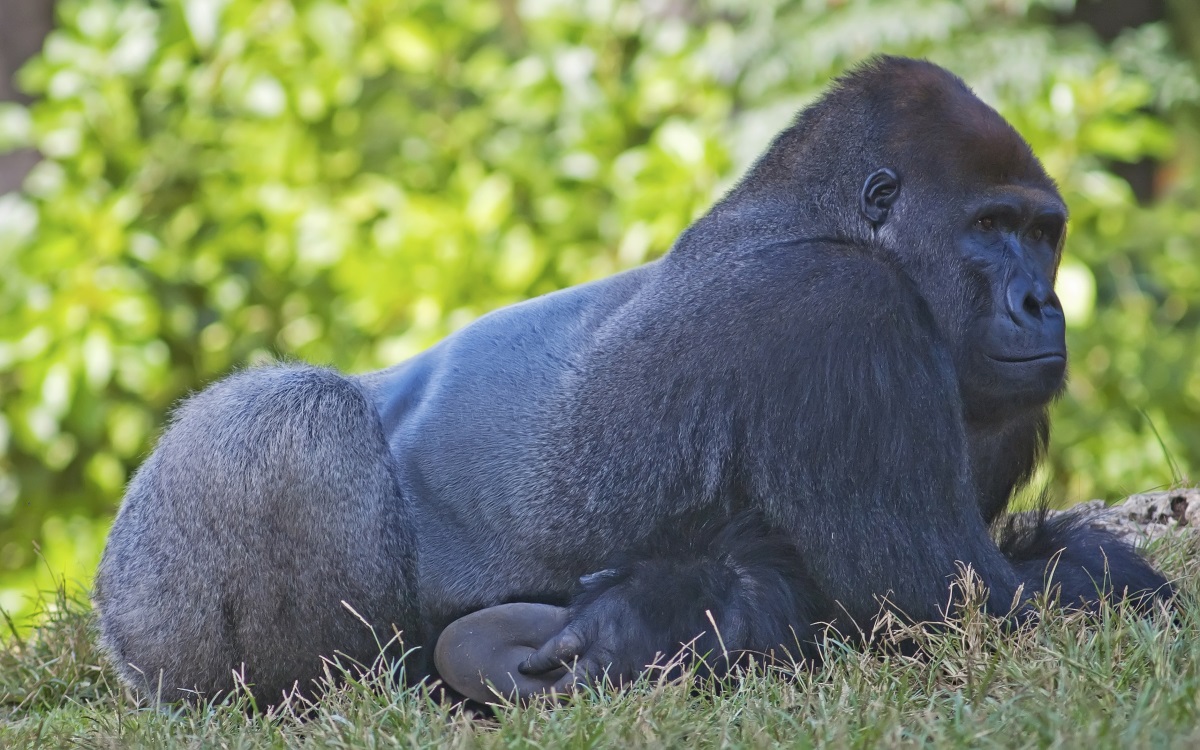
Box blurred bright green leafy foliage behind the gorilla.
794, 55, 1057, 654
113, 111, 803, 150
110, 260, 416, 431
0, 0, 1200, 619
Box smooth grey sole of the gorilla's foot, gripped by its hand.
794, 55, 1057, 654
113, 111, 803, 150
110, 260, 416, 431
433, 602, 574, 703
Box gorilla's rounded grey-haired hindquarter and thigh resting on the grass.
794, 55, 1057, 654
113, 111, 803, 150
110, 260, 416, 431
95, 367, 420, 703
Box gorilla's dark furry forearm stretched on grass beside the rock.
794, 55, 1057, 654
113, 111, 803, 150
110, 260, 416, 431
1000, 510, 1174, 612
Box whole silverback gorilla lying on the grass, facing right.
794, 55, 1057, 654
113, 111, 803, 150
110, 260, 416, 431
95, 58, 1171, 702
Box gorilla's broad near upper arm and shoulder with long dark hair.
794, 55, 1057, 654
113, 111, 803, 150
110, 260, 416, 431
740, 244, 1016, 626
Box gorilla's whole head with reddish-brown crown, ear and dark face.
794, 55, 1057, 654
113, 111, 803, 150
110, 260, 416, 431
859, 66, 1067, 422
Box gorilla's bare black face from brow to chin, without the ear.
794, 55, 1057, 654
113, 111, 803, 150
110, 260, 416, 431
955, 186, 1067, 418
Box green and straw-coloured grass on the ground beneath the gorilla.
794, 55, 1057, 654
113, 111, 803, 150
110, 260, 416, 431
0, 535, 1200, 750
